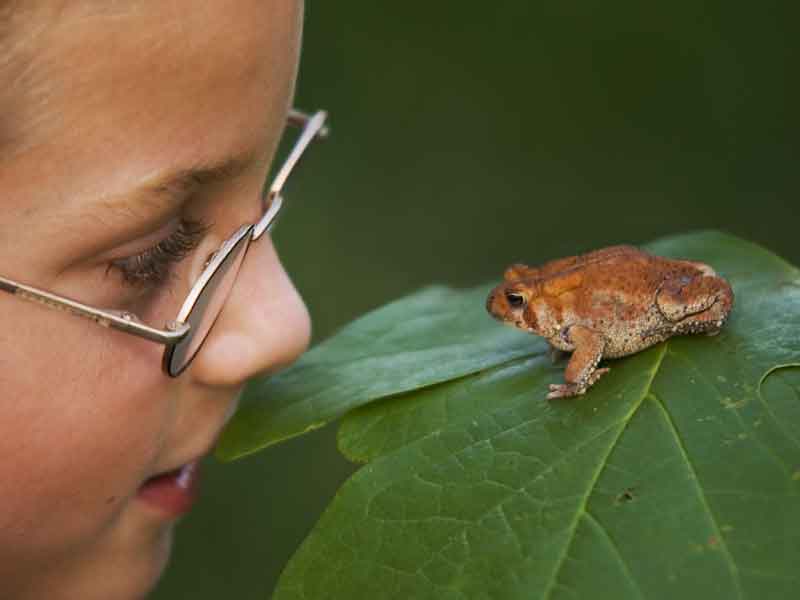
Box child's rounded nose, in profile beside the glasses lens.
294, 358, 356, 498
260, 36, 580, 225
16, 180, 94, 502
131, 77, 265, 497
190, 235, 311, 386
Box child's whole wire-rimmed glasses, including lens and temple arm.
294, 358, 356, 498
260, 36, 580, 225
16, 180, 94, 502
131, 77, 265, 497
0, 109, 328, 377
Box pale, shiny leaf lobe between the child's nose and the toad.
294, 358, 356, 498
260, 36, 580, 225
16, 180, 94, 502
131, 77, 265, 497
217, 286, 544, 460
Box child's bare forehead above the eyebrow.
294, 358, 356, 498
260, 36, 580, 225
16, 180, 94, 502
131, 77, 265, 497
0, 0, 300, 218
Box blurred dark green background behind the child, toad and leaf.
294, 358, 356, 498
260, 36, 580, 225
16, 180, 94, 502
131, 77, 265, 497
153, 0, 800, 600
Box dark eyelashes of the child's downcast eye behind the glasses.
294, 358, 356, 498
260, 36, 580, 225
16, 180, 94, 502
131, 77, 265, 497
108, 219, 209, 288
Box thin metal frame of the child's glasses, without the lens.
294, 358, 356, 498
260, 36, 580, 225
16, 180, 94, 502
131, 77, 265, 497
0, 108, 329, 377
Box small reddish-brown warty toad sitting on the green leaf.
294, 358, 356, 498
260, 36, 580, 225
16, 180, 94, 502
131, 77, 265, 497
486, 246, 733, 398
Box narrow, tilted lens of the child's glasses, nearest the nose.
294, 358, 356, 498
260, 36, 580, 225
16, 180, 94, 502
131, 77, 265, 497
164, 230, 252, 377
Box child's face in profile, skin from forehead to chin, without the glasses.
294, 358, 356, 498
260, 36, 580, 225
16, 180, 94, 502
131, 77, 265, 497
0, 0, 309, 600
